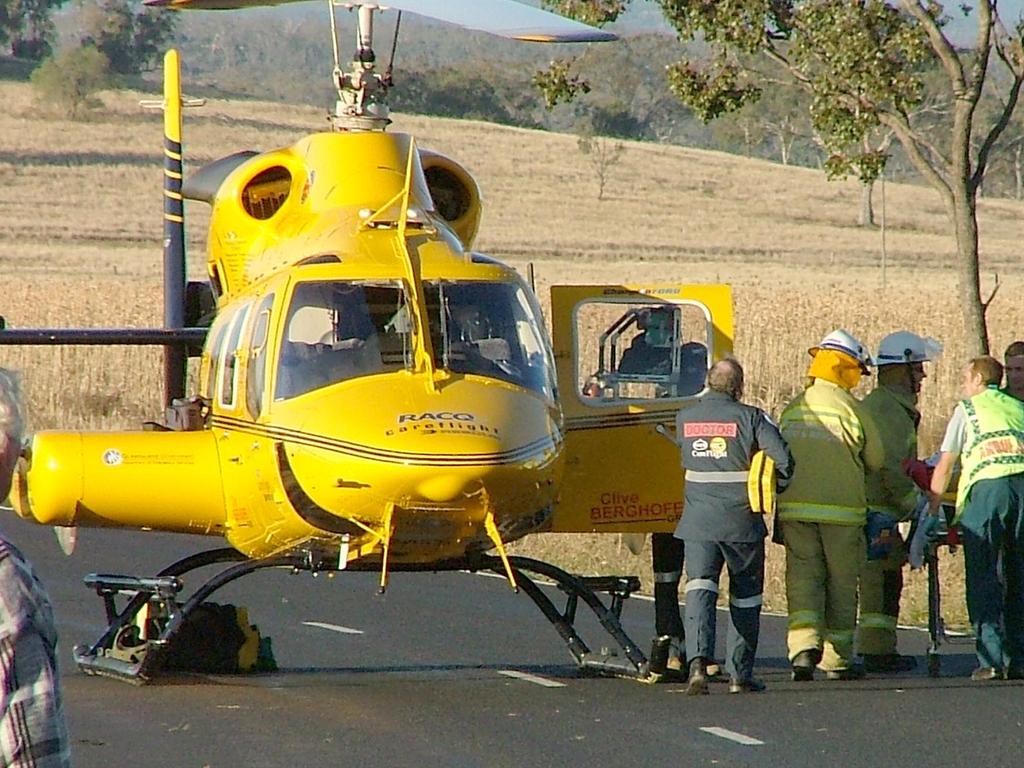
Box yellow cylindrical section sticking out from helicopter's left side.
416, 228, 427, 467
11, 431, 226, 534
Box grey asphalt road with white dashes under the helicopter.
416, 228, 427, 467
0, 514, 1024, 768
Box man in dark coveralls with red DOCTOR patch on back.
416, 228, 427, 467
676, 358, 794, 695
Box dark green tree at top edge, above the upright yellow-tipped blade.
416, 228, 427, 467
82, 0, 176, 75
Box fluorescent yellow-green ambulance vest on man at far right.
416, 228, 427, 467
956, 388, 1024, 510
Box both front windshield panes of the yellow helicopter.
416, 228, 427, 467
274, 281, 555, 399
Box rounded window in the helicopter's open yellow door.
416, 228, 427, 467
575, 301, 712, 404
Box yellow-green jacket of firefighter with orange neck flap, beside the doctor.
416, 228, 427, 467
778, 379, 885, 525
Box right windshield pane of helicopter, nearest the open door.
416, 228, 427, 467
424, 281, 554, 397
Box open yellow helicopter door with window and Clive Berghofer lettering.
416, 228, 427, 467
551, 285, 733, 532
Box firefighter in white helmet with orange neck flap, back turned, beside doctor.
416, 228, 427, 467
778, 330, 885, 681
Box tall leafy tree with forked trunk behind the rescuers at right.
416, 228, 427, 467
546, 0, 1024, 353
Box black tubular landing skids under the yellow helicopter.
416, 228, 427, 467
74, 548, 649, 685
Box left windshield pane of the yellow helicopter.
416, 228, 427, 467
274, 281, 412, 399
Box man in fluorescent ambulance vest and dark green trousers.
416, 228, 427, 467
929, 356, 1024, 681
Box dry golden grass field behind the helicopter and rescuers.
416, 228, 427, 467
0, 82, 1024, 621
